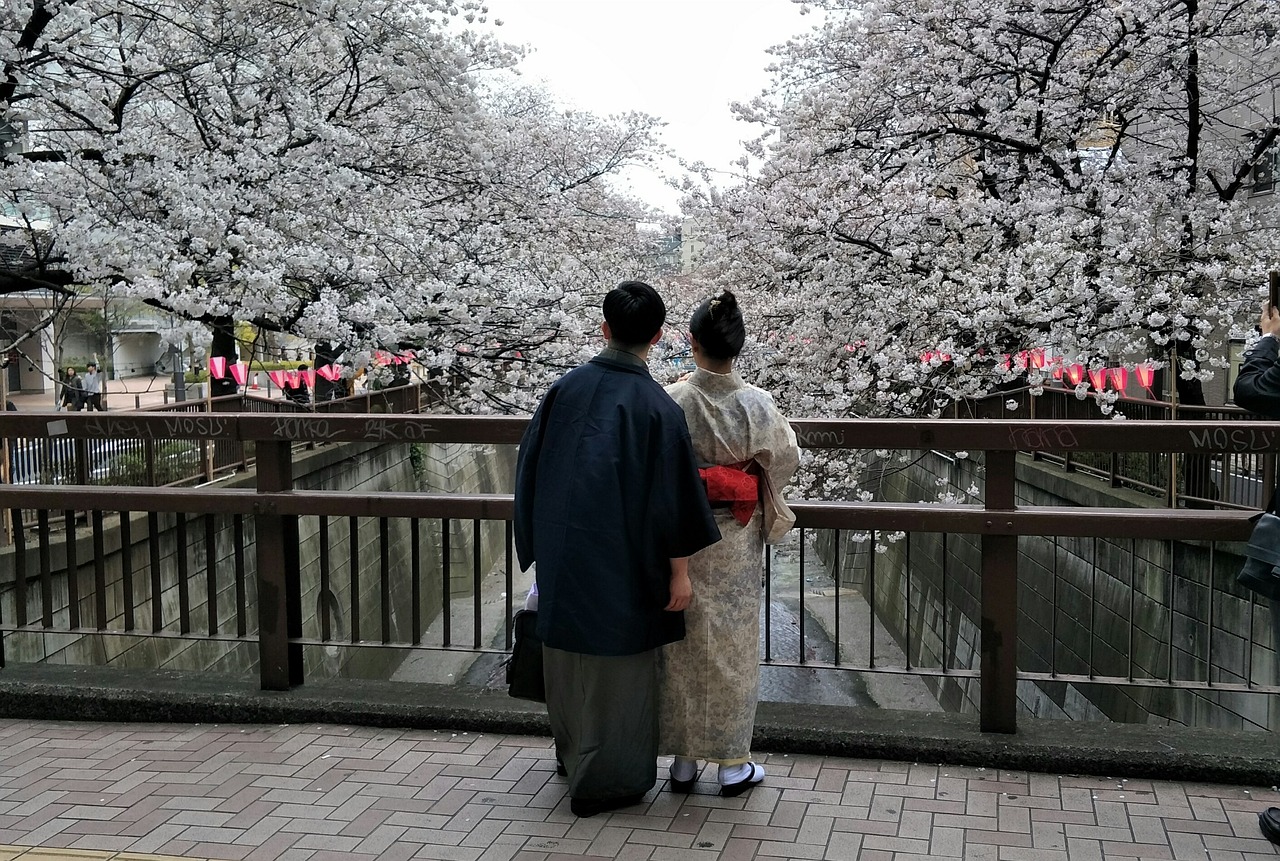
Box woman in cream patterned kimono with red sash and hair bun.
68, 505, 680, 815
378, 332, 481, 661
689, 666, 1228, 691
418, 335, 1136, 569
658, 290, 799, 796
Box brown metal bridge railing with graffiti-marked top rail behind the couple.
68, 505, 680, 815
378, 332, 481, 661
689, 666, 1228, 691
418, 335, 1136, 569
0, 413, 1264, 732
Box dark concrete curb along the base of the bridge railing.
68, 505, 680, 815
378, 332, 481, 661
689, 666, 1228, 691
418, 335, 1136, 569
0, 664, 1280, 786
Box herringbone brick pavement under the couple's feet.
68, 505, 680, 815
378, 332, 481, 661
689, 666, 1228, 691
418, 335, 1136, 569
0, 720, 1280, 861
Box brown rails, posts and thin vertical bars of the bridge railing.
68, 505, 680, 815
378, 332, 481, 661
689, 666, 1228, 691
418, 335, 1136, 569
0, 413, 1280, 732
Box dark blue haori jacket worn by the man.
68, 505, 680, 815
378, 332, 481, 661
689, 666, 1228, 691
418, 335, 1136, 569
515, 349, 719, 656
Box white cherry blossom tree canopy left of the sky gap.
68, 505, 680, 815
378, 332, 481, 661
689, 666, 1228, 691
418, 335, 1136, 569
0, 0, 658, 408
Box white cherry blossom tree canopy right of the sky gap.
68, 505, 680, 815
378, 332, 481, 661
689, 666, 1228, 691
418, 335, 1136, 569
690, 0, 1280, 415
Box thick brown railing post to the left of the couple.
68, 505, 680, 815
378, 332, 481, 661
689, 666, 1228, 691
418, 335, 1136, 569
253, 440, 302, 691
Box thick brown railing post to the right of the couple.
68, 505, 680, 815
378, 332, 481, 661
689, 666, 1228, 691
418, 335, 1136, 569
979, 452, 1018, 733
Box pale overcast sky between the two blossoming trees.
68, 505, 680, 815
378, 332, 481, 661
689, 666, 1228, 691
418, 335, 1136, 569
488, 0, 814, 212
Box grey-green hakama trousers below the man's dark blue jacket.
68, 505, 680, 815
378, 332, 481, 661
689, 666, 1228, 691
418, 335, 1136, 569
543, 646, 658, 801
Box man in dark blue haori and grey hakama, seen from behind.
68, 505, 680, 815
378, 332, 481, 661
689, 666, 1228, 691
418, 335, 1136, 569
515, 281, 719, 816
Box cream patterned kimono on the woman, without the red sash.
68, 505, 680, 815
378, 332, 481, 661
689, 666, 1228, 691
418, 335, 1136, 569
659, 368, 800, 765
